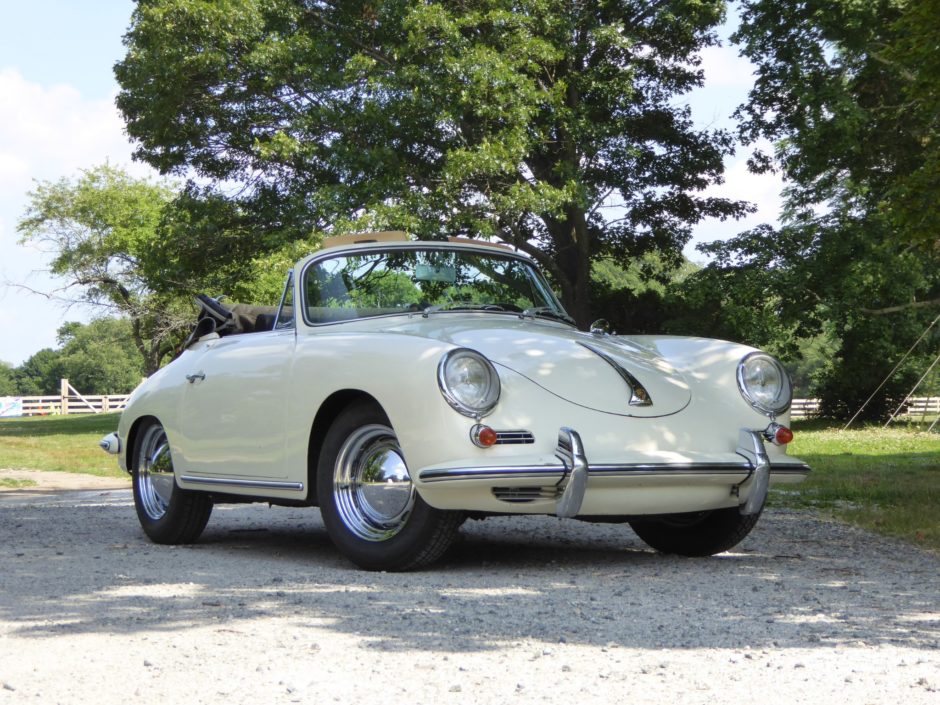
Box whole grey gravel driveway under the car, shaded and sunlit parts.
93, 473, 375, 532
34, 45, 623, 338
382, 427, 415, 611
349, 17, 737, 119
0, 478, 940, 705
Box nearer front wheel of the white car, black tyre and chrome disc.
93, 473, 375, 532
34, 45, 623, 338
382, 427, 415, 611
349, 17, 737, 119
317, 402, 464, 571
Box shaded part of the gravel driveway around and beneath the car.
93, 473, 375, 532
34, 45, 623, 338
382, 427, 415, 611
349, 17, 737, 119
0, 493, 940, 652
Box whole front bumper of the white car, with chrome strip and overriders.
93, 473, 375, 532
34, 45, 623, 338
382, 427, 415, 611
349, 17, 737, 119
418, 427, 809, 517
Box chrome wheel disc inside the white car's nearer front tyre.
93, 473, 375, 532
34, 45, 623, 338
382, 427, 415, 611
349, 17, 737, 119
333, 424, 415, 541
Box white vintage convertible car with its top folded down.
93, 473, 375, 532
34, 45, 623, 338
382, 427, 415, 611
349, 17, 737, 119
101, 233, 809, 570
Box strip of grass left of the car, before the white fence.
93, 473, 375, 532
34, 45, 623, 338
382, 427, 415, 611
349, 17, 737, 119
0, 414, 127, 477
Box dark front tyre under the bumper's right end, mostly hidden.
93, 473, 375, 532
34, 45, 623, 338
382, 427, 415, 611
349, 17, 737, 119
630, 507, 760, 556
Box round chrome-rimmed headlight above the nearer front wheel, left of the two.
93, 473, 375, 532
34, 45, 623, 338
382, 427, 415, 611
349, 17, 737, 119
437, 348, 499, 418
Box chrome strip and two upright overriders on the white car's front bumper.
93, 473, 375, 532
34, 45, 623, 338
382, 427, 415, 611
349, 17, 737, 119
418, 427, 809, 517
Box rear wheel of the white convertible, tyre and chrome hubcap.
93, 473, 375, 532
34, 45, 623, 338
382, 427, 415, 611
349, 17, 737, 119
132, 421, 212, 544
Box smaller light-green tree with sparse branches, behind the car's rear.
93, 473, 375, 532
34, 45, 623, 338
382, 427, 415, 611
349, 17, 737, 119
17, 165, 191, 374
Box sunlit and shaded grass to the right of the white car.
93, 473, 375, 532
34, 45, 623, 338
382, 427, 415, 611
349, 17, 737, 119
769, 421, 940, 551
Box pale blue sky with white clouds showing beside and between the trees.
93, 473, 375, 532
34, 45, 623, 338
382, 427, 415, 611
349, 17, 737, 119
0, 0, 780, 365
